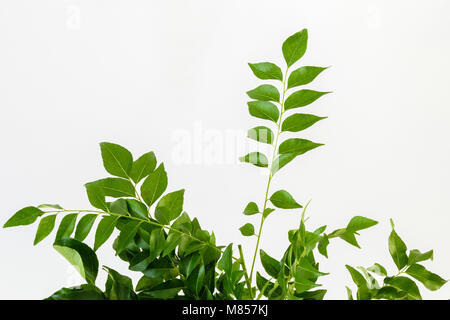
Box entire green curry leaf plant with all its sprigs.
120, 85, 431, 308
4, 29, 446, 300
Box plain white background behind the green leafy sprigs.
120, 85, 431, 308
0, 0, 450, 299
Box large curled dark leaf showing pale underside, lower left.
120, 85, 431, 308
53, 238, 98, 284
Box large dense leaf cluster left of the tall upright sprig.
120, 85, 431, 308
4, 142, 246, 299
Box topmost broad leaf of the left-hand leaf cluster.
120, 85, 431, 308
100, 142, 133, 178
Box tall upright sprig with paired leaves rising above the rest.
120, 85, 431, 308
240, 29, 329, 290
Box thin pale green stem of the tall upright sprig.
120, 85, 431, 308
250, 67, 289, 290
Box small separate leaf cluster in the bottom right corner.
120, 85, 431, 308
346, 220, 447, 300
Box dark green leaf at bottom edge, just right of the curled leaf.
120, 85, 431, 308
103, 267, 137, 300
